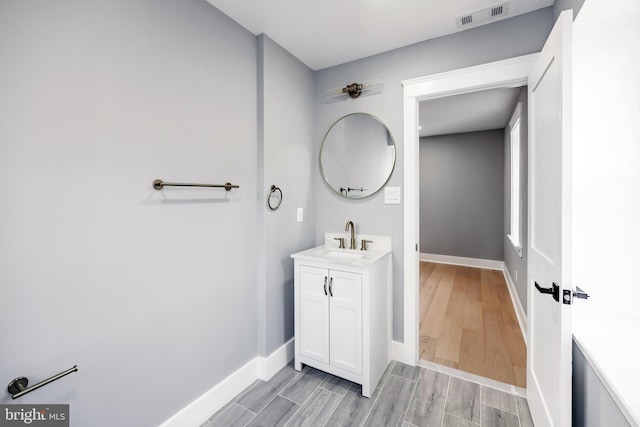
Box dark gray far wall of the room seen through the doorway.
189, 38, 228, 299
420, 129, 505, 261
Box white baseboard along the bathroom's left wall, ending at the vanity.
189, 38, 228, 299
160, 338, 294, 427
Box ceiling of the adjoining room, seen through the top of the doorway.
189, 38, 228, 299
420, 88, 519, 136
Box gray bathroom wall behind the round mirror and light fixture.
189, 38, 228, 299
315, 8, 553, 341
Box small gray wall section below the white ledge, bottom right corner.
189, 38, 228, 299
573, 342, 631, 427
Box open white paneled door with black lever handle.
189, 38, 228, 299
527, 11, 573, 427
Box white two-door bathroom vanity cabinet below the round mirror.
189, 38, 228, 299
292, 239, 391, 397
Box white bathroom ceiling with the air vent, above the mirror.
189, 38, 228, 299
207, 0, 554, 70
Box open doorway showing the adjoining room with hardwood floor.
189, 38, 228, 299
419, 87, 527, 388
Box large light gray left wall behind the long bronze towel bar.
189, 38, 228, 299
0, 0, 262, 426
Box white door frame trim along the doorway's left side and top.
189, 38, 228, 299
400, 53, 538, 366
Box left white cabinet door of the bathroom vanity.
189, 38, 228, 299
298, 265, 329, 363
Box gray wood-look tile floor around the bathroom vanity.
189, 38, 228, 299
201, 362, 533, 427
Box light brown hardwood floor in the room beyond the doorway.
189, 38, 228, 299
420, 262, 527, 388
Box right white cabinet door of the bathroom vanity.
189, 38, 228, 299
329, 270, 362, 375
